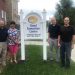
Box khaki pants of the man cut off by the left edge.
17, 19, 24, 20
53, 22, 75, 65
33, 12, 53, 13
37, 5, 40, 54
0, 42, 7, 65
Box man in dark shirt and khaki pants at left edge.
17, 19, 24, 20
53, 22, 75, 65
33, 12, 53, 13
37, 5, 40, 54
0, 19, 8, 69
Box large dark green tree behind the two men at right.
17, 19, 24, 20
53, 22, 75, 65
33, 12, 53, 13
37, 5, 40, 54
55, 0, 75, 25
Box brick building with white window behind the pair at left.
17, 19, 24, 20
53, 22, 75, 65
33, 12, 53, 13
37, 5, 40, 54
0, 0, 19, 24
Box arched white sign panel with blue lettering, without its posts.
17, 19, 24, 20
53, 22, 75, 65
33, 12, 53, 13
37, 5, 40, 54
24, 12, 43, 39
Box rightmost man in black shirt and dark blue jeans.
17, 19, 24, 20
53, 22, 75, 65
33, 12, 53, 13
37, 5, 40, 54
58, 17, 75, 68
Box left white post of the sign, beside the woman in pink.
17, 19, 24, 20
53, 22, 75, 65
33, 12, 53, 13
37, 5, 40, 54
20, 10, 25, 60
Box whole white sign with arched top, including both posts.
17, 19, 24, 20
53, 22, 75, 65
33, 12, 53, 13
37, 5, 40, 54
20, 10, 47, 60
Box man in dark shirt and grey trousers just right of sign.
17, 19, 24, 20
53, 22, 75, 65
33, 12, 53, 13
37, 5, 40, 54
48, 17, 60, 62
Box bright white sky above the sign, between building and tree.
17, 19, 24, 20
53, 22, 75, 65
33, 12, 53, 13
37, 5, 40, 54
18, 0, 59, 19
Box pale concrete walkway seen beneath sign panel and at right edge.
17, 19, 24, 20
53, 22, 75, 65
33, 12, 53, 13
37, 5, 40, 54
25, 41, 75, 62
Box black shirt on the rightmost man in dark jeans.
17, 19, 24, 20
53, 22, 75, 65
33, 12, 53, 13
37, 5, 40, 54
59, 26, 75, 42
